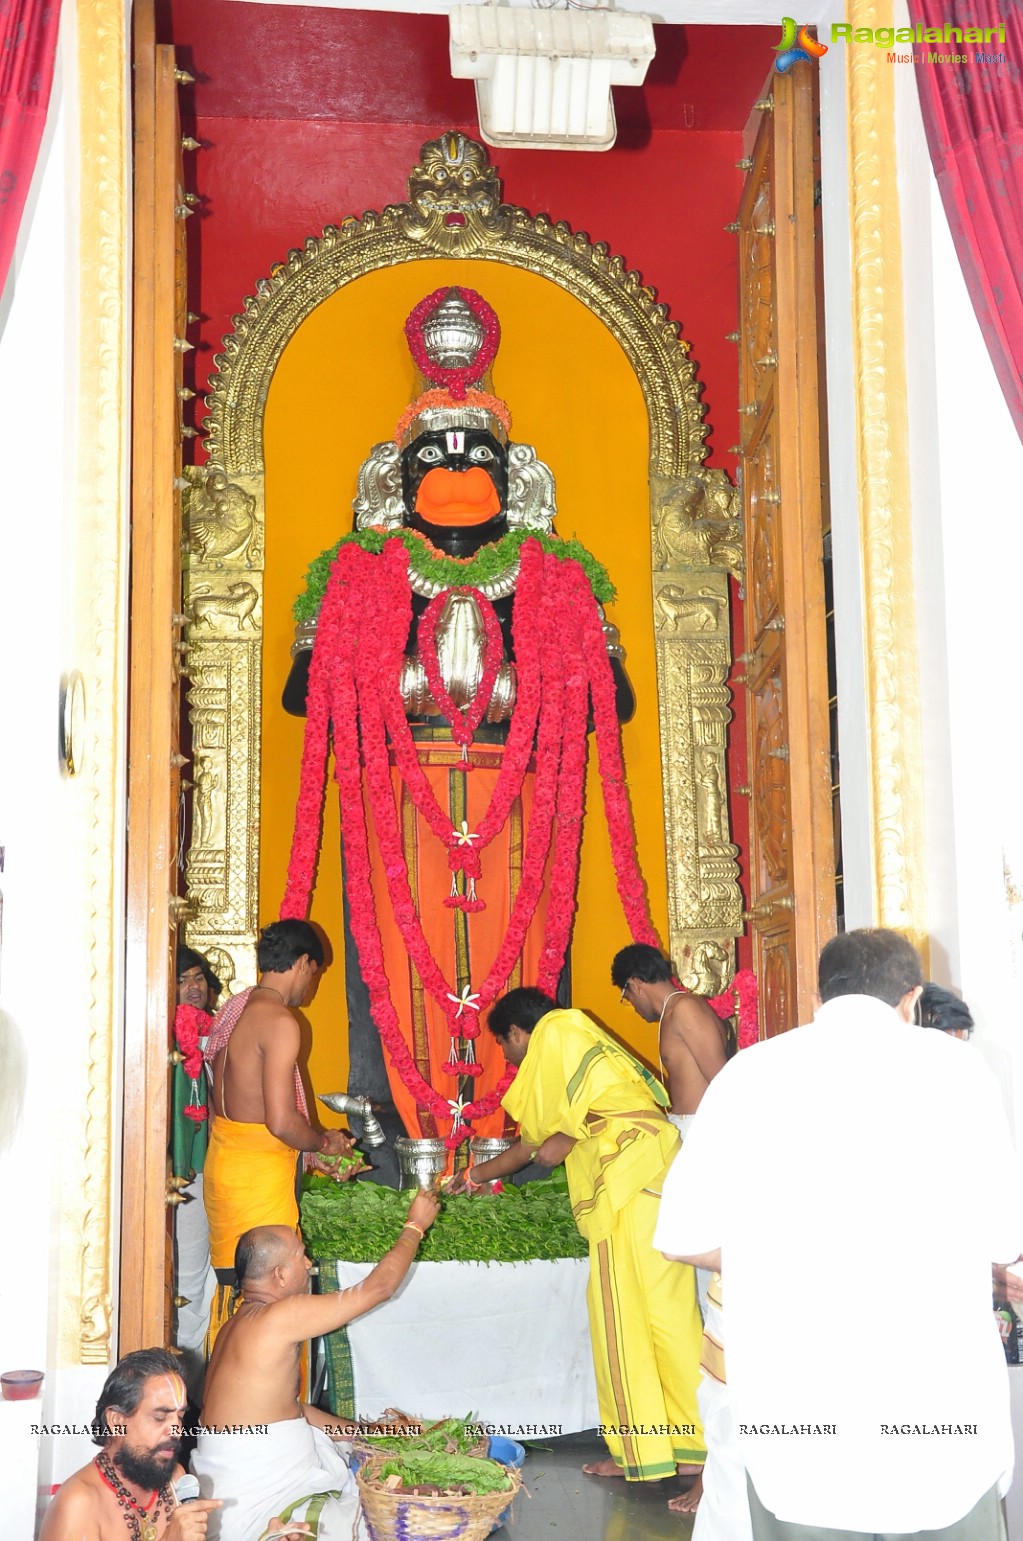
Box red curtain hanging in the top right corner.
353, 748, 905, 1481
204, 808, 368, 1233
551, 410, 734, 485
909, 0, 1023, 439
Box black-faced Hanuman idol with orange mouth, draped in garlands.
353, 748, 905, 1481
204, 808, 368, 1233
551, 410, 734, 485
282, 288, 656, 1148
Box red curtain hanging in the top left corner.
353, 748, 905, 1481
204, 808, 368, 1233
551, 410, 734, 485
0, 0, 60, 291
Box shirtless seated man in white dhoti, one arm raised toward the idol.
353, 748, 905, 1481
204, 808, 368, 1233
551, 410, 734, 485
193, 1193, 439, 1541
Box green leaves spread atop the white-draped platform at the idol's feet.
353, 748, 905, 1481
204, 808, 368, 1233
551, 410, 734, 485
302, 1173, 587, 1262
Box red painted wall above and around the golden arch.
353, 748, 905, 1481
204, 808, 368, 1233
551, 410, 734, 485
162, 0, 758, 949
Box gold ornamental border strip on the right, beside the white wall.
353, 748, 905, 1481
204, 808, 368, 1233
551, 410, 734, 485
847, 0, 927, 951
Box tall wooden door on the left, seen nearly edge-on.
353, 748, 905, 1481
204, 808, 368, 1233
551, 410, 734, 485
119, 0, 188, 1353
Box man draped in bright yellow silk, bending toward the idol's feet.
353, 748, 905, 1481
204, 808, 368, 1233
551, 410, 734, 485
456, 989, 706, 1481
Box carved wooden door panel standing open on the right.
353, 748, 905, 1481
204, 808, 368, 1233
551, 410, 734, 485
740, 65, 835, 1036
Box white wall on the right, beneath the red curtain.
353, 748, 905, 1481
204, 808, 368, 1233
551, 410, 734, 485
897, 48, 1023, 1142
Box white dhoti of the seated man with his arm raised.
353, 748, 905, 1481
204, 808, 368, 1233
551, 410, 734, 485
191, 1418, 367, 1541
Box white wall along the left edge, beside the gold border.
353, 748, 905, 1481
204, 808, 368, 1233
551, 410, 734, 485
0, 6, 123, 1541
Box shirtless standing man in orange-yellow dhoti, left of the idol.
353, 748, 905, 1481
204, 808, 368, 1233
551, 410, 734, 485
205, 920, 356, 1355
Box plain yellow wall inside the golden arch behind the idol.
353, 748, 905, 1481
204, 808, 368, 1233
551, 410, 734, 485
259, 260, 667, 1115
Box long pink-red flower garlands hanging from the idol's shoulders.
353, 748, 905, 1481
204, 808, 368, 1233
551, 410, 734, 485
280, 539, 746, 1145
